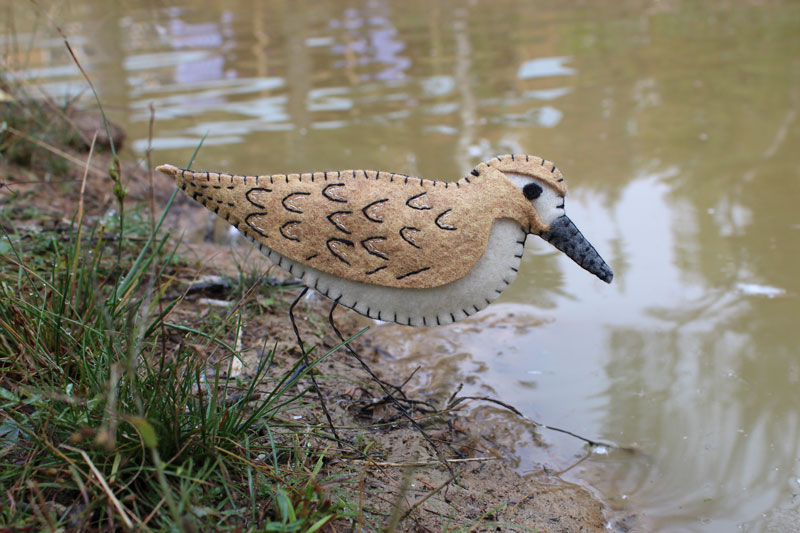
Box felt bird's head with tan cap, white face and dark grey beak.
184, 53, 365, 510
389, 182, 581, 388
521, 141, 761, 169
486, 155, 614, 283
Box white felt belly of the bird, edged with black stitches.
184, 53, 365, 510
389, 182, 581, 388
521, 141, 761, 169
250, 219, 527, 326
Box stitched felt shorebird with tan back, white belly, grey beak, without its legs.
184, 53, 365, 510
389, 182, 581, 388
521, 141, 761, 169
157, 155, 613, 326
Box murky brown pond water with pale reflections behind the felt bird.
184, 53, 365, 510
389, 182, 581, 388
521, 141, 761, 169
7, 0, 800, 532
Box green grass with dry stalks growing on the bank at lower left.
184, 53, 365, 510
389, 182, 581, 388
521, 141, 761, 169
0, 169, 356, 531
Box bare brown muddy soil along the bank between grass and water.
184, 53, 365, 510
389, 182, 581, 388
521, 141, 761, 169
0, 121, 624, 532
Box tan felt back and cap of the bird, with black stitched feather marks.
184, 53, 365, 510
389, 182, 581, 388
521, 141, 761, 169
158, 155, 566, 288
